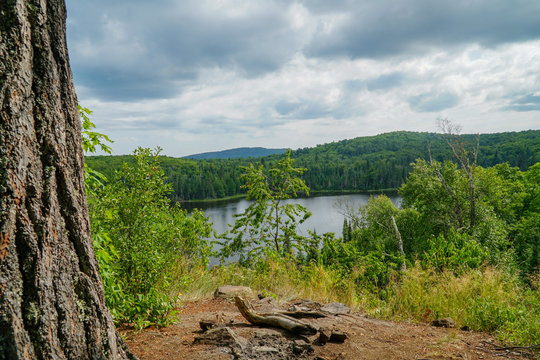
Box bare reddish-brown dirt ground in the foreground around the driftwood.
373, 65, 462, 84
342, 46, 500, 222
121, 299, 536, 360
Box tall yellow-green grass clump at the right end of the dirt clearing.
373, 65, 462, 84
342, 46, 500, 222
380, 265, 540, 344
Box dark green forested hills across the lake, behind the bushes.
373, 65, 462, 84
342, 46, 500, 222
86, 130, 540, 200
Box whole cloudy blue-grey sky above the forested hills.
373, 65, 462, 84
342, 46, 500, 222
67, 0, 540, 156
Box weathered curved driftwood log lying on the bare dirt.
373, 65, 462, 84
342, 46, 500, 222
234, 296, 317, 335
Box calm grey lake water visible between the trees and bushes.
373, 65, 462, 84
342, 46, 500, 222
186, 194, 401, 237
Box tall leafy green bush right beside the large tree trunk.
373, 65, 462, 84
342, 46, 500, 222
89, 149, 212, 328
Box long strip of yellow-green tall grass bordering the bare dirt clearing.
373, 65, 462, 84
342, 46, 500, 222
178, 259, 540, 345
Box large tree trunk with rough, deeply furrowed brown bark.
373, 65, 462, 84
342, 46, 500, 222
0, 0, 133, 359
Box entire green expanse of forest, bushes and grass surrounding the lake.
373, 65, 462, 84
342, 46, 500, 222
80, 109, 540, 349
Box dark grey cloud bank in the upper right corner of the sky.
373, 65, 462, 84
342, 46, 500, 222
306, 0, 540, 58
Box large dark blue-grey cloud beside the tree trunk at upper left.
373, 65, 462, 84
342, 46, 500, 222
68, 0, 299, 100
